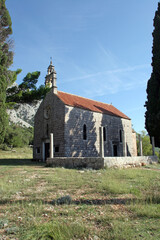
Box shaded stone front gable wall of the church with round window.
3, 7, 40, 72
33, 90, 64, 160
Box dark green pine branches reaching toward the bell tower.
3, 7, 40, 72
7, 71, 50, 103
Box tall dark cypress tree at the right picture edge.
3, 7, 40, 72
145, 2, 160, 147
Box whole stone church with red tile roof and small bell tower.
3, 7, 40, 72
33, 61, 137, 161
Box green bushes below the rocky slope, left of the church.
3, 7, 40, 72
1, 124, 33, 147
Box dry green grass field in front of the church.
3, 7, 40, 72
0, 149, 160, 240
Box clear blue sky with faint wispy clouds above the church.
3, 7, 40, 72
6, 0, 158, 132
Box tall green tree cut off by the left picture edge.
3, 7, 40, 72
0, 0, 15, 143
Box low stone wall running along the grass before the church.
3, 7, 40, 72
46, 156, 157, 170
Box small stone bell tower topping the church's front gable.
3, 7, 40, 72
45, 58, 57, 94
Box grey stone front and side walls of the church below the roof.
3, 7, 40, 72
33, 90, 138, 160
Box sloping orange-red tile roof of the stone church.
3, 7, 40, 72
58, 91, 130, 120
